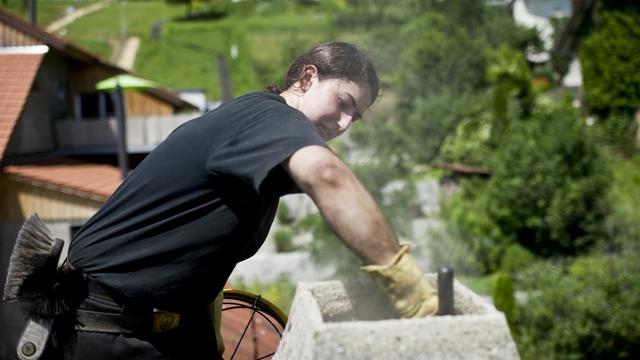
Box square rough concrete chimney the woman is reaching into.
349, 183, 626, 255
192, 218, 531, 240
273, 274, 520, 360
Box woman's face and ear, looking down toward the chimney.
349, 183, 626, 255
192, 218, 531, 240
298, 74, 371, 141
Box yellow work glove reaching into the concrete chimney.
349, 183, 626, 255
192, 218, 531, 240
362, 244, 438, 318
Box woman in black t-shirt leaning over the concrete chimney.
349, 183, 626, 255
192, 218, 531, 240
7, 42, 437, 360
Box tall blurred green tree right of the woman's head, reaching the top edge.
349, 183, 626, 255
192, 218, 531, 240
344, 0, 534, 164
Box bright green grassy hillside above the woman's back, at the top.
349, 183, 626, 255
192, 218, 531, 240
56, 1, 358, 99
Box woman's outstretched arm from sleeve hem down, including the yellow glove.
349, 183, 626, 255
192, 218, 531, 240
283, 146, 438, 318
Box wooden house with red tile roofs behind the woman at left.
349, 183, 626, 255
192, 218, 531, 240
0, 10, 200, 359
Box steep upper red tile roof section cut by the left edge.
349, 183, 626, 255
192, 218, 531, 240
0, 54, 42, 159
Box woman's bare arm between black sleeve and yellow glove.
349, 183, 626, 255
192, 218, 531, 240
282, 146, 400, 265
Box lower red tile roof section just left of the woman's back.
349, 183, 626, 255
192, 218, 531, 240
2, 160, 121, 200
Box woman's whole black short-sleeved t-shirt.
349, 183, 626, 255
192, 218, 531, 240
69, 92, 326, 310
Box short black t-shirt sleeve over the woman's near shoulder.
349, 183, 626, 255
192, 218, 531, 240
207, 104, 327, 192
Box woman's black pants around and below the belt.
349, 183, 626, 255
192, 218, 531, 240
43, 281, 221, 360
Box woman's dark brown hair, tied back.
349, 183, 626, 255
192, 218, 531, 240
267, 42, 379, 103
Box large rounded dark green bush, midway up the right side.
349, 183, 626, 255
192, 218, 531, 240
485, 105, 609, 256
